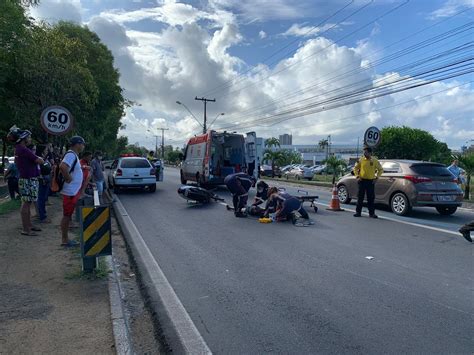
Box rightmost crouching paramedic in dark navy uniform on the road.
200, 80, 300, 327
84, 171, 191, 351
266, 187, 309, 224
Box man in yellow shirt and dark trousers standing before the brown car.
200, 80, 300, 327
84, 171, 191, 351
354, 147, 383, 218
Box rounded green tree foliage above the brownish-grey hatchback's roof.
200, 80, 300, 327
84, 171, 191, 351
375, 126, 451, 163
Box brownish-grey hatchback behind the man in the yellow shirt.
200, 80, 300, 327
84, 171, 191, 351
337, 160, 463, 216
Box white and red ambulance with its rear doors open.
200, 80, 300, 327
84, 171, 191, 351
180, 131, 261, 187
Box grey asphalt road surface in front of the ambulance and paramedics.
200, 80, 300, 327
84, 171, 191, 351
119, 169, 474, 354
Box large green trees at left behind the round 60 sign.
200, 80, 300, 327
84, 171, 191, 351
0, 1, 125, 158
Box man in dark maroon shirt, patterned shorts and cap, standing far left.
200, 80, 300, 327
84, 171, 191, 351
10, 129, 44, 236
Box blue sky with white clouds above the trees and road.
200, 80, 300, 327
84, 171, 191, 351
30, 0, 474, 149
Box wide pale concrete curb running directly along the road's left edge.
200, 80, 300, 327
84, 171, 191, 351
113, 195, 212, 354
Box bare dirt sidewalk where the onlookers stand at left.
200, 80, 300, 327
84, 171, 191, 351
0, 197, 115, 354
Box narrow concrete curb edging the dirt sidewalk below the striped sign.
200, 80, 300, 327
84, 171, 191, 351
105, 256, 134, 355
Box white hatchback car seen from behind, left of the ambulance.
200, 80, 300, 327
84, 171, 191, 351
105, 155, 156, 193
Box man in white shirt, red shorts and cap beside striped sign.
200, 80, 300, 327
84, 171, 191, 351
59, 136, 86, 247
